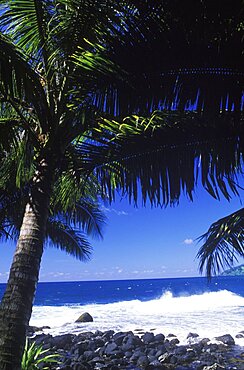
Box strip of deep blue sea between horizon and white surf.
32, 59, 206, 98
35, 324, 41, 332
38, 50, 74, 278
0, 276, 244, 306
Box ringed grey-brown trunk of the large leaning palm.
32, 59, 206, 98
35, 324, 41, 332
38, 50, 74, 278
0, 158, 53, 370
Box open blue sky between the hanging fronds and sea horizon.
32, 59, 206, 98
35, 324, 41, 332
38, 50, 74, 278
0, 184, 243, 282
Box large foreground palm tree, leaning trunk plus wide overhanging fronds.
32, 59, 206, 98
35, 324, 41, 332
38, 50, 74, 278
0, 0, 243, 370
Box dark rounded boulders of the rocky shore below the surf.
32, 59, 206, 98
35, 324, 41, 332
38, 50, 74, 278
29, 328, 244, 370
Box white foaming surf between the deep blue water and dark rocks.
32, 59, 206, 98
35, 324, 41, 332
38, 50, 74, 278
30, 290, 244, 345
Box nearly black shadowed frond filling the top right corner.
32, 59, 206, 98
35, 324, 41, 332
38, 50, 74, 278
101, 0, 244, 116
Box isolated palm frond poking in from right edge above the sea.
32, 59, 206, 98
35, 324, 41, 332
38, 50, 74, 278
197, 208, 244, 278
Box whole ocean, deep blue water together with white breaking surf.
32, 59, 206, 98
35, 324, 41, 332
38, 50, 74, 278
0, 276, 244, 345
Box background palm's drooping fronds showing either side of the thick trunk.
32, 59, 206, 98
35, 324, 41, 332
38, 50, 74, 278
0, 184, 105, 261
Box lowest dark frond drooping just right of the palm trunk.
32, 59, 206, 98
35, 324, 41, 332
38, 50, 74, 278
46, 218, 92, 261
